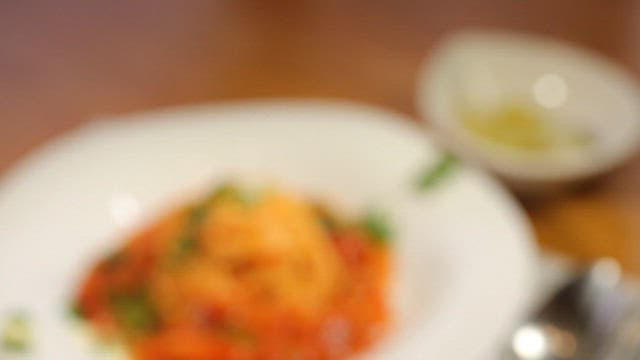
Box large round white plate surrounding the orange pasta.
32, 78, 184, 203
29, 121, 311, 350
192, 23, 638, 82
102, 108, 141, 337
0, 101, 534, 360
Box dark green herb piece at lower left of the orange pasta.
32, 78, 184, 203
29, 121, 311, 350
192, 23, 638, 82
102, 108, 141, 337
111, 291, 158, 334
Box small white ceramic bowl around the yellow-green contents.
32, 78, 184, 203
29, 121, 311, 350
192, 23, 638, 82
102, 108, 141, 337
416, 31, 640, 190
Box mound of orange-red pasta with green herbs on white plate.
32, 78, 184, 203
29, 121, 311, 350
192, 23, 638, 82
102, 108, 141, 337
77, 186, 389, 360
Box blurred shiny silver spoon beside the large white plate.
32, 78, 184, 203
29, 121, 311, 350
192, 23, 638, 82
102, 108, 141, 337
501, 259, 640, 360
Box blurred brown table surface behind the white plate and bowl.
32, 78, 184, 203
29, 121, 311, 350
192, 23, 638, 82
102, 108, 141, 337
0, 0, 640, 274
